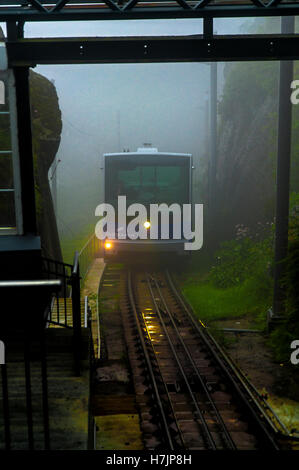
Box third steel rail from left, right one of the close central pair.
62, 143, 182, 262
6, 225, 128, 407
154, 272, 236, 450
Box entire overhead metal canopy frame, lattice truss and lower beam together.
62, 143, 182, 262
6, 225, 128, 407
0, 0, 299, 67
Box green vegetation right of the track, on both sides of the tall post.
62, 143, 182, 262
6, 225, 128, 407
182, 193, 299, 373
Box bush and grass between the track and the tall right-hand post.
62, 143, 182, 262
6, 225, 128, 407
183, 220, 273, 328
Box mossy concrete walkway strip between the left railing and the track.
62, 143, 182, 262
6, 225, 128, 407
91, 265, 143, 450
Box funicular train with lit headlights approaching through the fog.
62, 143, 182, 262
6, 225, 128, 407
103, 146, 192, 260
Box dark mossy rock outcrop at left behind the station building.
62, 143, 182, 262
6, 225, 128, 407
30, 70, 62, 261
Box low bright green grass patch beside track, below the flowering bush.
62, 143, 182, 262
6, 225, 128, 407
182, 279, 271, 328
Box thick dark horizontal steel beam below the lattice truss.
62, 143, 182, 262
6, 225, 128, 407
7, 34, 299, 67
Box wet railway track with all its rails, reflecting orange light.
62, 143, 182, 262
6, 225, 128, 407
121, 271, 279, 450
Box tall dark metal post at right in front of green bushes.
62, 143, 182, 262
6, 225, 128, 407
273, 17, 295, 318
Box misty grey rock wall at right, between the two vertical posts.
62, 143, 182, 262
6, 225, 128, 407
215, 65, 277, 239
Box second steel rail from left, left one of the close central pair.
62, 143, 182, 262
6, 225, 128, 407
146, 273, 217, 450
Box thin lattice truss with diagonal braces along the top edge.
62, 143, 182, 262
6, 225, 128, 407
0, 0, 299, 21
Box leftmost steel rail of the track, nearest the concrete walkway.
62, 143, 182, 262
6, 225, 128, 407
127, 271, 175, 450
